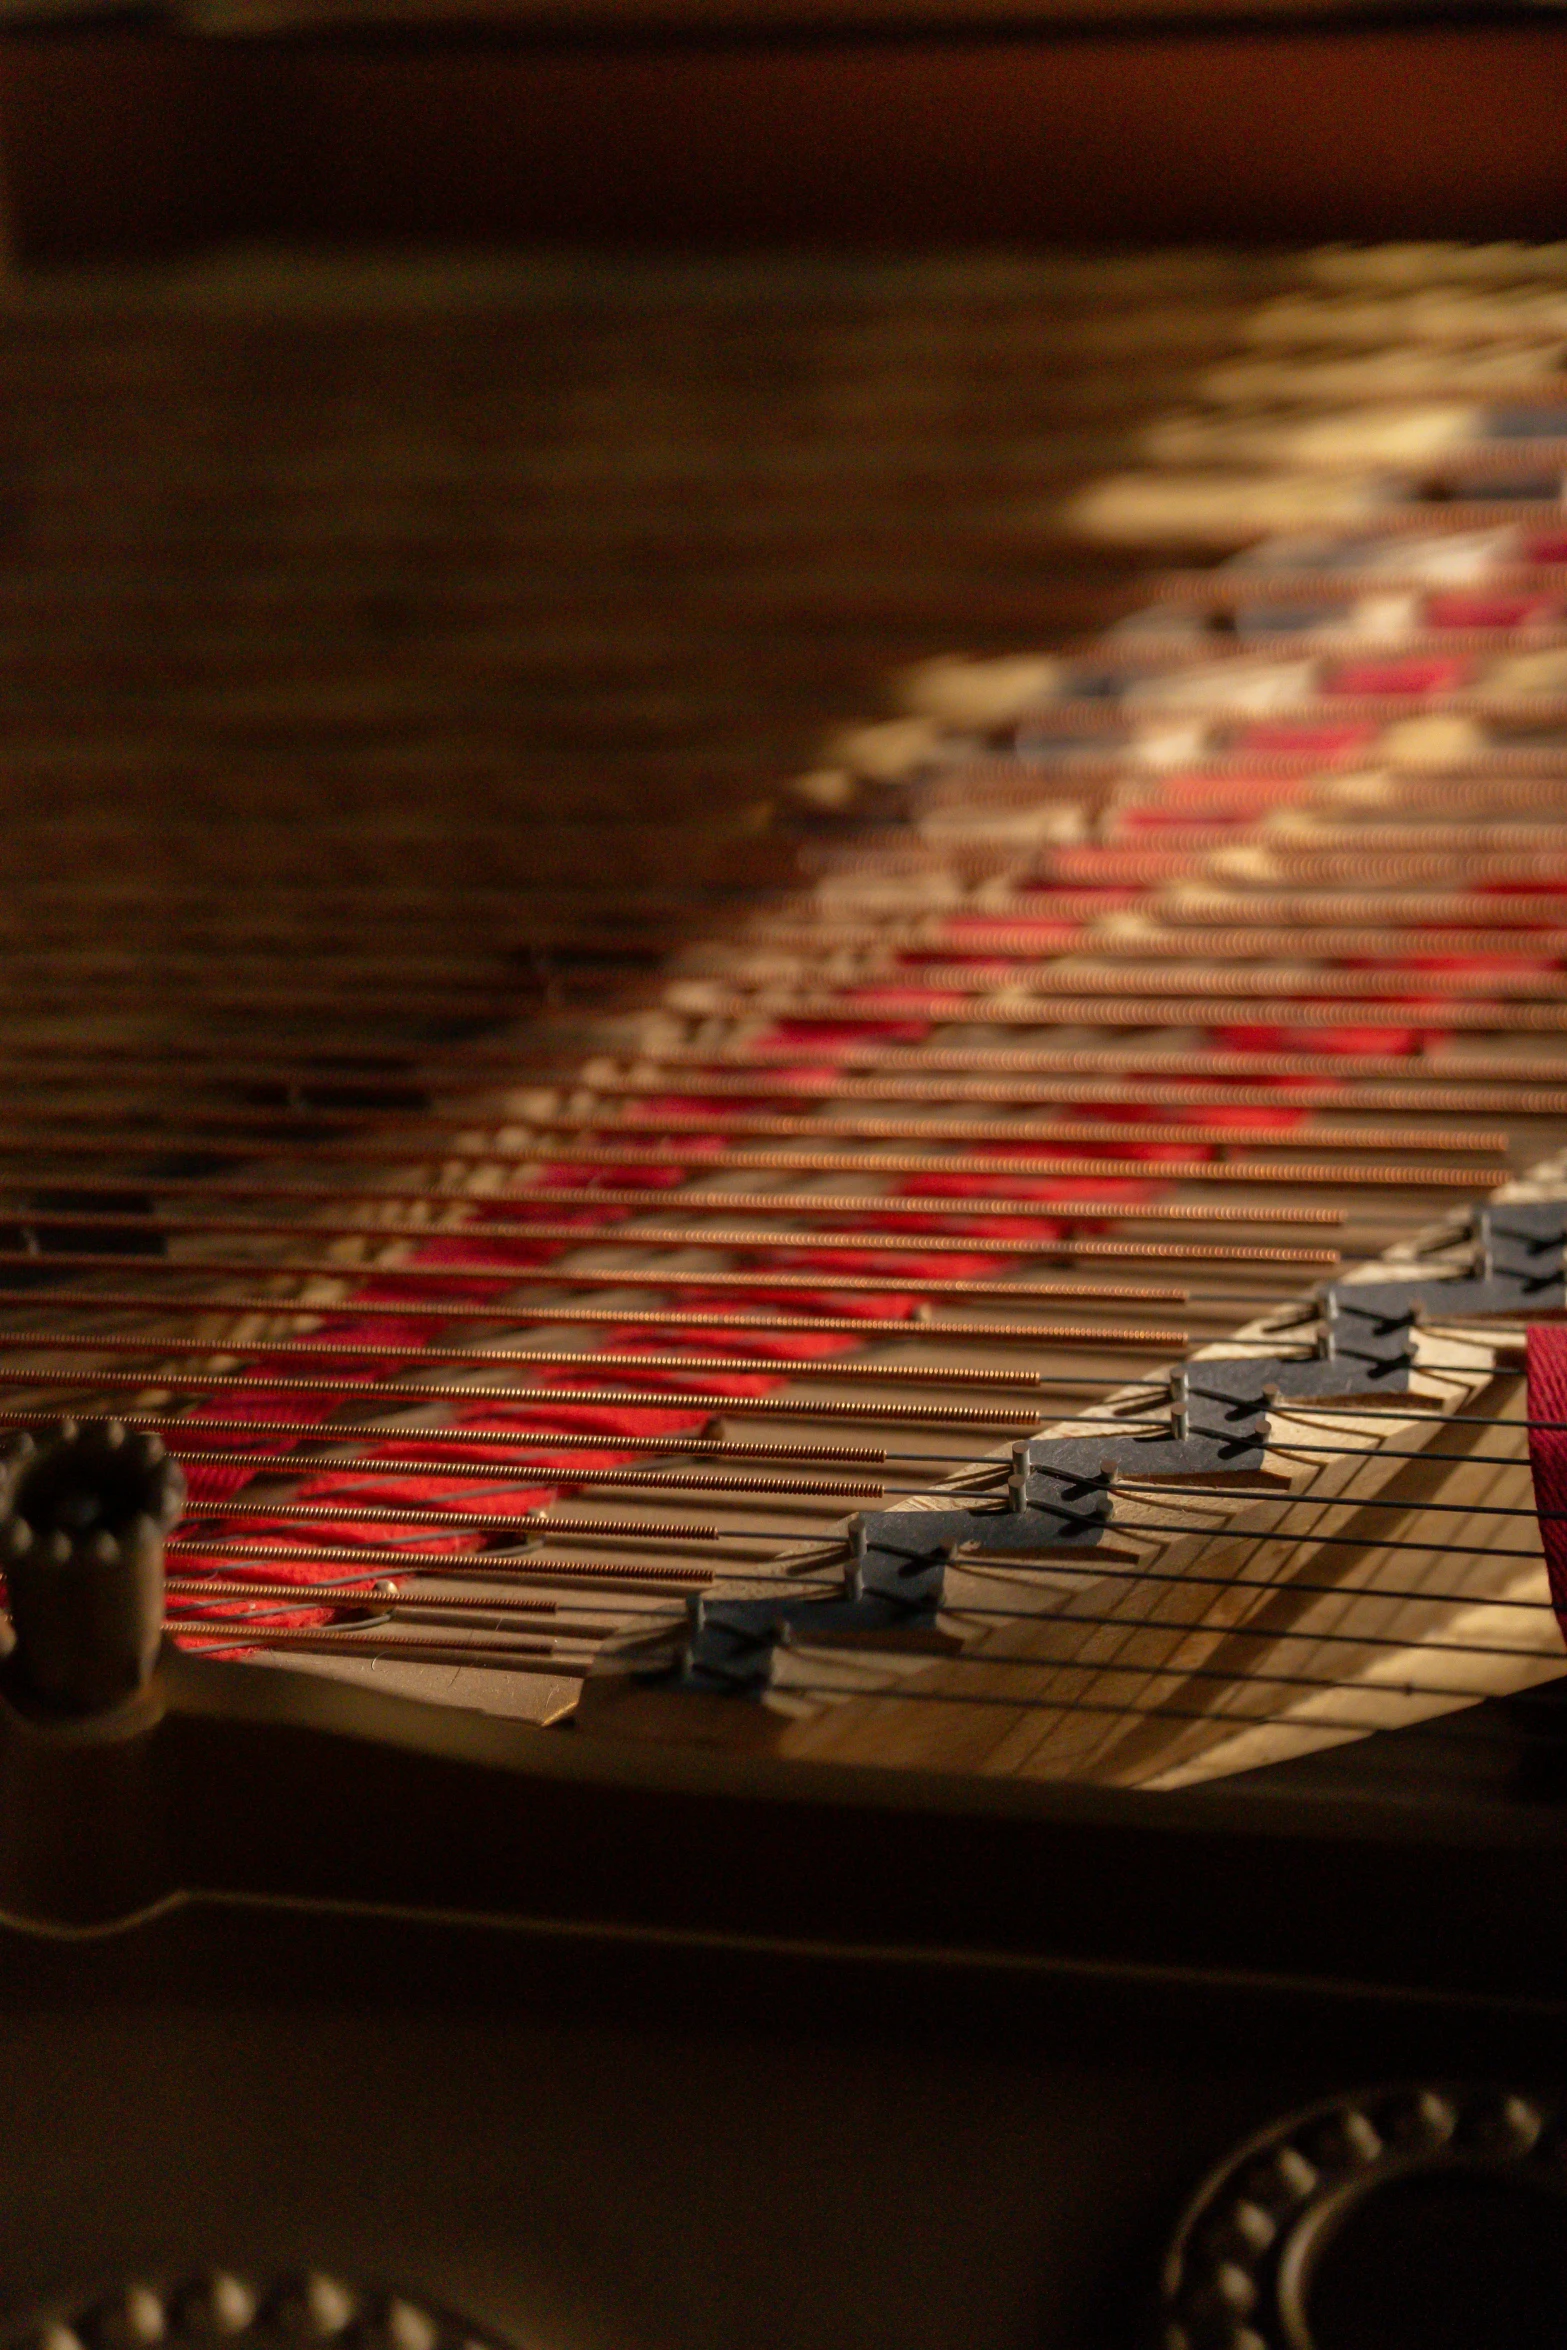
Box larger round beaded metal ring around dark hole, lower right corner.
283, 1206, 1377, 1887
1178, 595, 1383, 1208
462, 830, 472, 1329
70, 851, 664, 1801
1156, 2082, 1567, 2350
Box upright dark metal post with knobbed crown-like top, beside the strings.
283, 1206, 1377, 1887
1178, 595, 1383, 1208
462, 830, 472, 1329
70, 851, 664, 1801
0, 1419, 186, 1718
